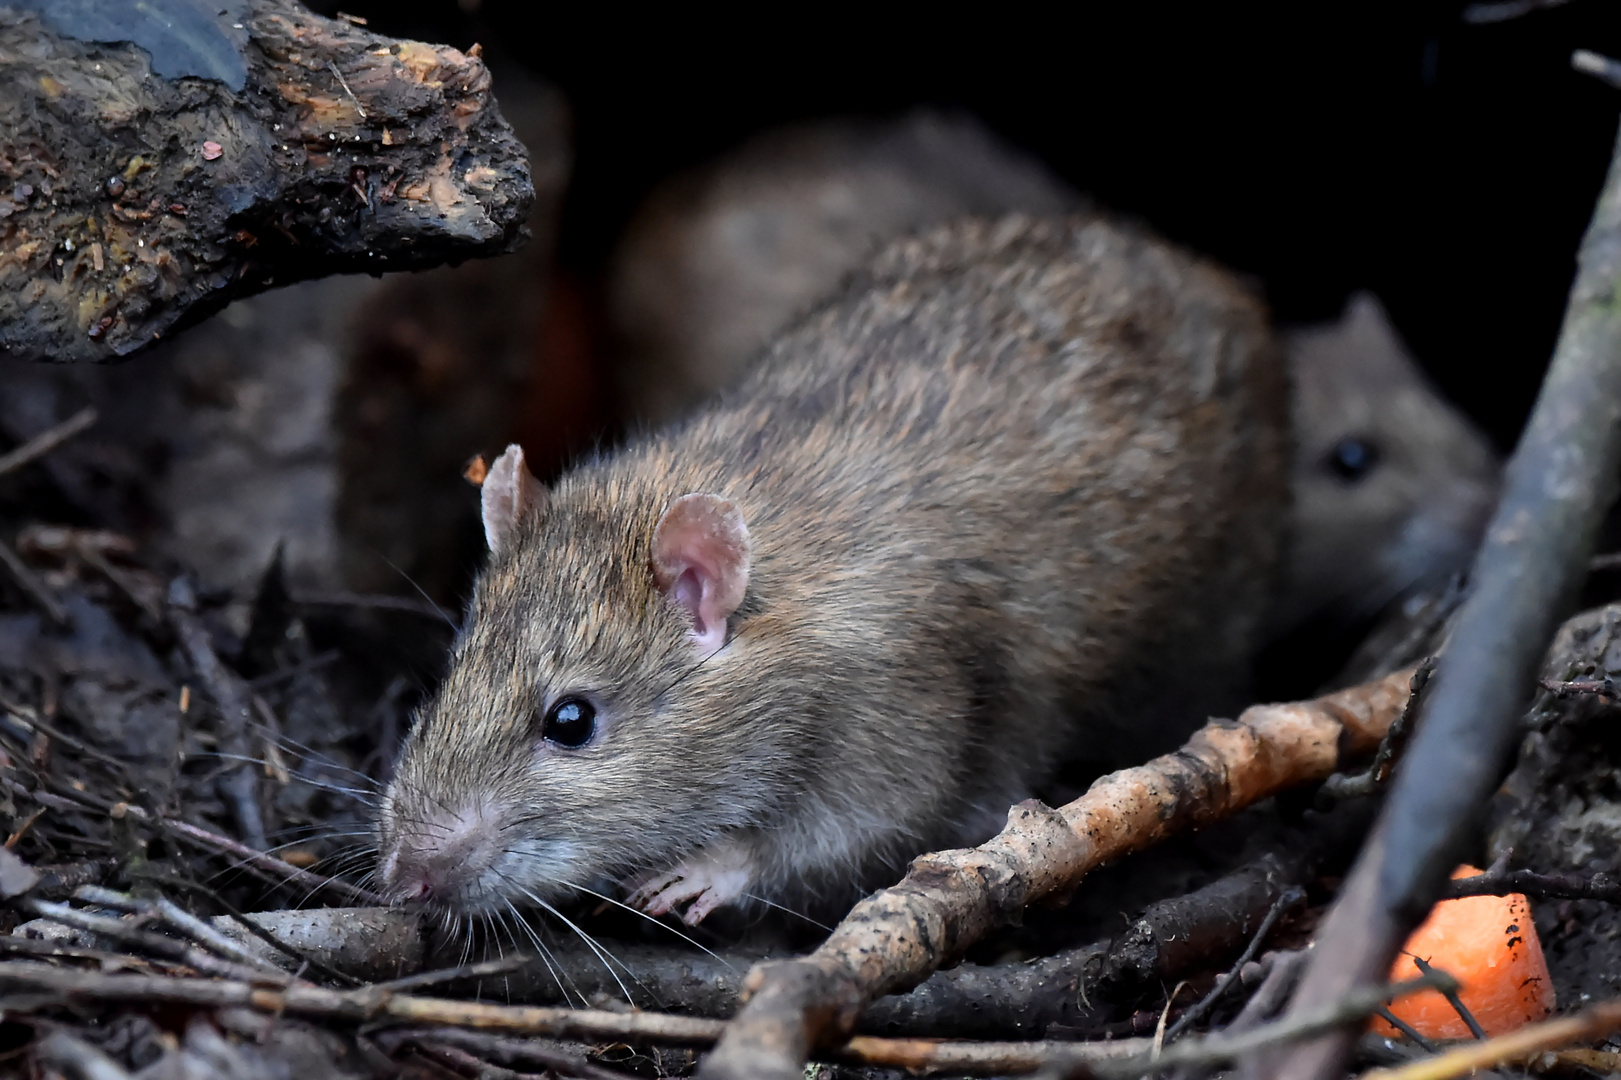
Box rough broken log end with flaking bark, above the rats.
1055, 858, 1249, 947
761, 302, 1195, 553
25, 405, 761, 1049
0, 0, 533, 360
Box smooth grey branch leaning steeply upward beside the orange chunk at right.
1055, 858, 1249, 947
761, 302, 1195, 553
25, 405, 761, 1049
1263, 109, 1621, 1080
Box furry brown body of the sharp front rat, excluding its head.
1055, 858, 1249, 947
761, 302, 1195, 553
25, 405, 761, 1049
609, 217, 1287, 901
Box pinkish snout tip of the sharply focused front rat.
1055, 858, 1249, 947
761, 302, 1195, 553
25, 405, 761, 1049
378, 794, 499, 908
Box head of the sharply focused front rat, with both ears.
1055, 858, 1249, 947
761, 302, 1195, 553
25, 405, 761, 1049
378, 446, 751, 911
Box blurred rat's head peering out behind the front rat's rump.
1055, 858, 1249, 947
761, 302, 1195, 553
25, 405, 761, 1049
1277, 292, 1498, 629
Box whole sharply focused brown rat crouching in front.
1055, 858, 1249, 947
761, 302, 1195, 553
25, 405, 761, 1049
378, 217, 1285, 921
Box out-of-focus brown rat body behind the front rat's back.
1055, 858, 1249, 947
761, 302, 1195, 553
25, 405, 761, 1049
608, 109, 1086, 423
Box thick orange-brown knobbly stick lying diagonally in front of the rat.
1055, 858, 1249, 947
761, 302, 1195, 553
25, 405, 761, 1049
699, 671, 1412, 1080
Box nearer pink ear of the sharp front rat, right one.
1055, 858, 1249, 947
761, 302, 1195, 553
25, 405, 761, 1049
653, 495, 749, 654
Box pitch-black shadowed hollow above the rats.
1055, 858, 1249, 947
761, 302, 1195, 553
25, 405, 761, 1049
313, 0, 1621, 448
